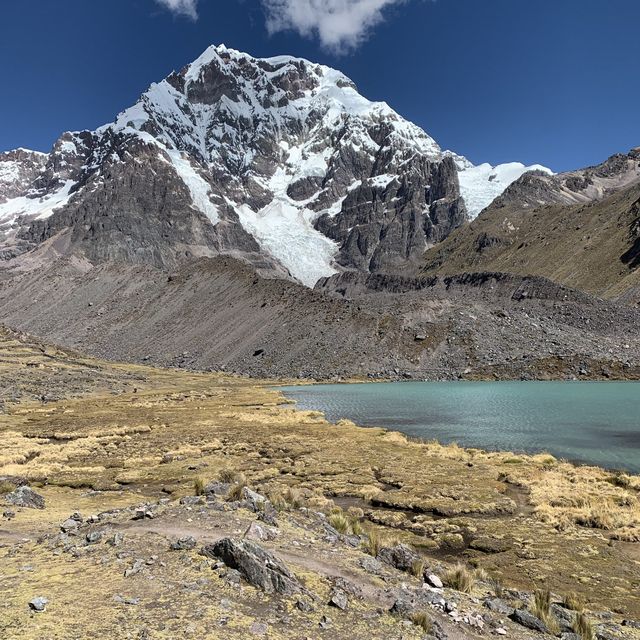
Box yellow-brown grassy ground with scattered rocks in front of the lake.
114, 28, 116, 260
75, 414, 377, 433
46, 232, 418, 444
0, 332, 640, 640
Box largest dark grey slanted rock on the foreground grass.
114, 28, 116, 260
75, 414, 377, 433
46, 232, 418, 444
202, 538, 302, 595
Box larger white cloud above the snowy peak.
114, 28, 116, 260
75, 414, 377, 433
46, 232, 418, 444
262, 0, 404, 52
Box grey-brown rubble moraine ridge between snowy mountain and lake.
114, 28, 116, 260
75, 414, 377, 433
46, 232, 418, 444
0, 258, 640, 380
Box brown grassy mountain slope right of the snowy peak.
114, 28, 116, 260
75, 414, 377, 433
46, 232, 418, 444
423, 149, 640, 304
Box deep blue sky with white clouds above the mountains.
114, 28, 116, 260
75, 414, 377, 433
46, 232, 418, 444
0, 0, 640, 171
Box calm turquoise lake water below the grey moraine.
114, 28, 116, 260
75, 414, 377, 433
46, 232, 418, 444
281, 382, 640, 473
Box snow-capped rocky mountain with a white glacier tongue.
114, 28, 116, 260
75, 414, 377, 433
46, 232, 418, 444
0, 46, 548, 286
